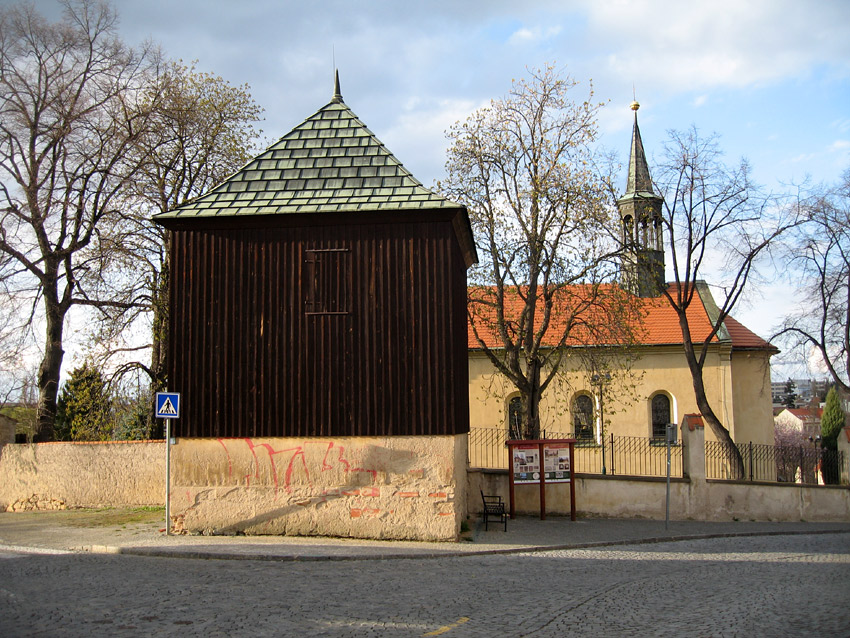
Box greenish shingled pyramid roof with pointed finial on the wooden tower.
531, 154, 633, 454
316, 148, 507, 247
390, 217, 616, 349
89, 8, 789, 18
155, 77, 462, 220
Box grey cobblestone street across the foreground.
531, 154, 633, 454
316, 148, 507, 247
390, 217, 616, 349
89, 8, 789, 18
0, 533, 850, 638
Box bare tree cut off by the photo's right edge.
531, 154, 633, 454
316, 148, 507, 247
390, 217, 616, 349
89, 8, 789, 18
775, 170, 850, 396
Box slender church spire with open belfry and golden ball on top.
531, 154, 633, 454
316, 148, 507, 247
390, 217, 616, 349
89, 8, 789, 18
617, 102, 664, 297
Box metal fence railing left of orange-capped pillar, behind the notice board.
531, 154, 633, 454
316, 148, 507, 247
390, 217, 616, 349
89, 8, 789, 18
469, 428, 682, 477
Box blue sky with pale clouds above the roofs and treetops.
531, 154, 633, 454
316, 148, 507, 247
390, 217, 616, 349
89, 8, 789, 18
29, 0, 850, 376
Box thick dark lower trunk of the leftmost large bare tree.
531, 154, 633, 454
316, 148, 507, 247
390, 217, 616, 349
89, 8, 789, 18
33, 296, 66, 441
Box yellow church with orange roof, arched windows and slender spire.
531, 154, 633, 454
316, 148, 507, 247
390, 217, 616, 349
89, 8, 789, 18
468, 103, 778, 450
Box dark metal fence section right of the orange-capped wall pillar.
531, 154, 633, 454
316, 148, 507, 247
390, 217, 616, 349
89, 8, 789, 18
705, 441, 845, 485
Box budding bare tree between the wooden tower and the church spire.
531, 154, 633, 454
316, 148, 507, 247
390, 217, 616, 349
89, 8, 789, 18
441, 67, 633, 438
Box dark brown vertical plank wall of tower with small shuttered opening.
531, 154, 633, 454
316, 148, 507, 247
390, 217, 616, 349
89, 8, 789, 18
169, 215, 469, 437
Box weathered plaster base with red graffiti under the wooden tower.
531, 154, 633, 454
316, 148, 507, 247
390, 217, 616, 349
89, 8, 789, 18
171, 436, 466, 541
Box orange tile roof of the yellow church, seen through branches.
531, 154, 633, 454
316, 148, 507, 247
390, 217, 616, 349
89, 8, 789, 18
467, 284, 775, 350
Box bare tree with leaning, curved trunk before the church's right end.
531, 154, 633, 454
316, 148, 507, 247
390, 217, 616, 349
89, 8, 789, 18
657, 128, 798, 473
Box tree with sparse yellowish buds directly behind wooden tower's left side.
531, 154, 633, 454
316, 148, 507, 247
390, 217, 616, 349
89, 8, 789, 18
90, 62, 262, 410
